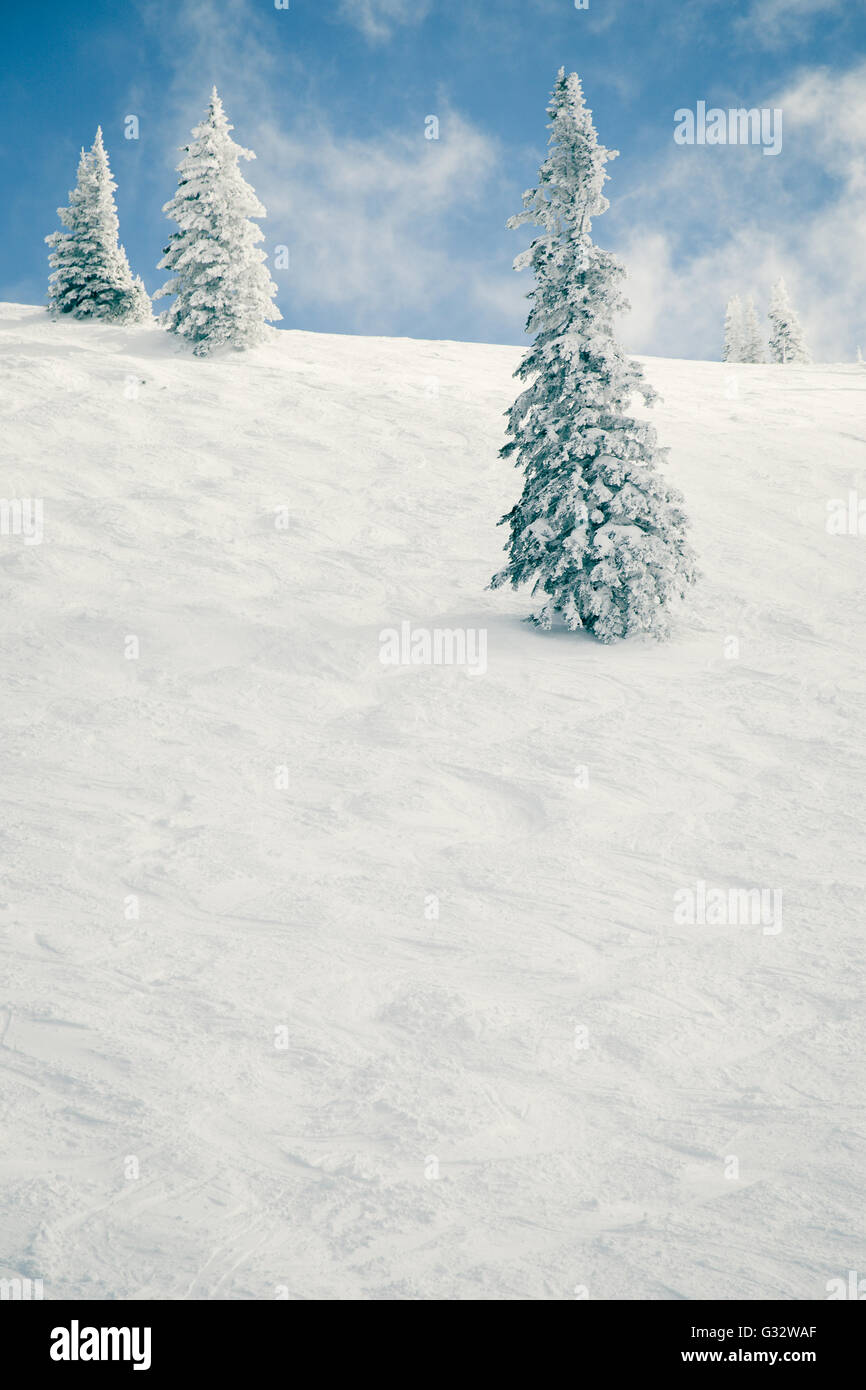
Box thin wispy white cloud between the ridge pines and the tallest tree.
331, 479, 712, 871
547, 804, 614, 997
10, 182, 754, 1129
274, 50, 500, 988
253, 110, 518, 336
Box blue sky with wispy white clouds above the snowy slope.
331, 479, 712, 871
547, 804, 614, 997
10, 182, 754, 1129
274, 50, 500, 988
0, 0, 866, 360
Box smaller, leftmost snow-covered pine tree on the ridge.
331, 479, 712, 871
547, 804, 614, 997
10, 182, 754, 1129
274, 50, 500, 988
46, 126, 150, 322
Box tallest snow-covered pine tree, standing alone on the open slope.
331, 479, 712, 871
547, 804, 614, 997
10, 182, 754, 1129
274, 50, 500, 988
491, 68, 695, 642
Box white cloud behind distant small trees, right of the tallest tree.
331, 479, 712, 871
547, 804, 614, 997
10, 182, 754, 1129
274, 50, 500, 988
614, 63, 866, 361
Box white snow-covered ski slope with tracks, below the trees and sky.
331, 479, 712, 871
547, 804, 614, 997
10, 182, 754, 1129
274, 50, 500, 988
0, 296, 866, 1300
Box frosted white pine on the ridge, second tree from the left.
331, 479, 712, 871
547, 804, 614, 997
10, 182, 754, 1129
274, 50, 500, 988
154, 88, 282, 357
